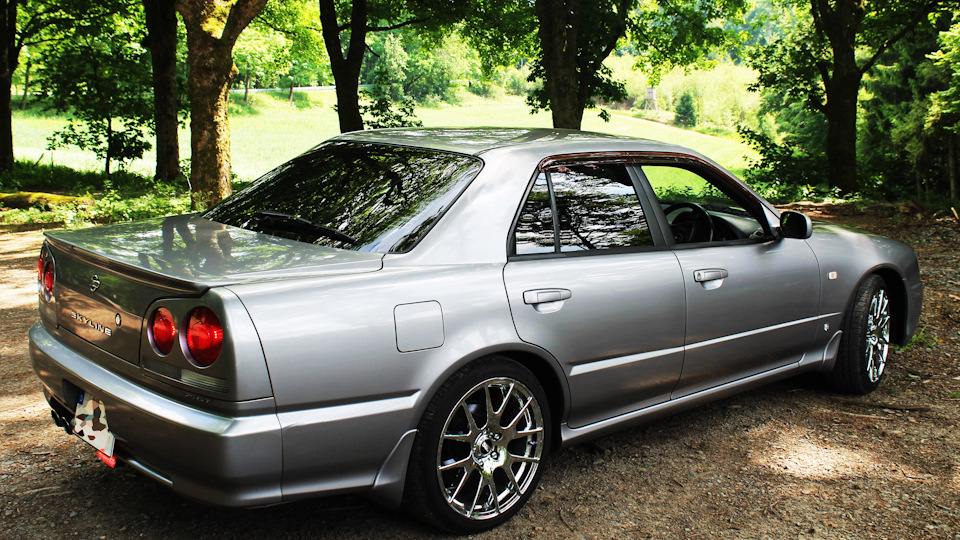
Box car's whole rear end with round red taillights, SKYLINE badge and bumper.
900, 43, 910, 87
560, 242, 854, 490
30, 224, 281, 506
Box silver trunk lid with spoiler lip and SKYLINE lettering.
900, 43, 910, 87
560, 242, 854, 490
41, 215, 382, 364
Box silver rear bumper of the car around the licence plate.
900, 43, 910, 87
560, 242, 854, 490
30, 324, 283, 506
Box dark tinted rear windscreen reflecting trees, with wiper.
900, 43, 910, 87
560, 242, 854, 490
204, 142, 482, 253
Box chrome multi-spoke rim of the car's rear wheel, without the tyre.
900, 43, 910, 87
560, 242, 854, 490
437, 377, 545, 520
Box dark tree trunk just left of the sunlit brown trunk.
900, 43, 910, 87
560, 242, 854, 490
143, 0, 180, 183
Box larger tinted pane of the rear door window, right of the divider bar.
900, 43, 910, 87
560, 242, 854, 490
550, 164, 653, 252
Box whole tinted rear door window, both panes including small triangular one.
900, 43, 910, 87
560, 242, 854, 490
515, 164, 653, 255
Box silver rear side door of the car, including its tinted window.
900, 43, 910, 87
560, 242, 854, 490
503, 163, 684, 427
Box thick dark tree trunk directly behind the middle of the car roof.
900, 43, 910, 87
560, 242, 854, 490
536, 0, 586, 129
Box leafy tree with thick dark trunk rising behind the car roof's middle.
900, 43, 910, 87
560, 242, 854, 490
464, 0, 746, 129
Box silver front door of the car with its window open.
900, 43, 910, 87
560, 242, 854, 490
640, 162, 820, 398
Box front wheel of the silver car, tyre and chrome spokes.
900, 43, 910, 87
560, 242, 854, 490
829, 275, 891, 394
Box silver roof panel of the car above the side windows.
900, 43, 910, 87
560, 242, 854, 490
332, 127, 698, 155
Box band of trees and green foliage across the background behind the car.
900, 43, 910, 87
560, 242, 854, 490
0, 0, 960, 208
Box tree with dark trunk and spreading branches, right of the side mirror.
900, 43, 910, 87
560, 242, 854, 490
754, 0, 956, 193
